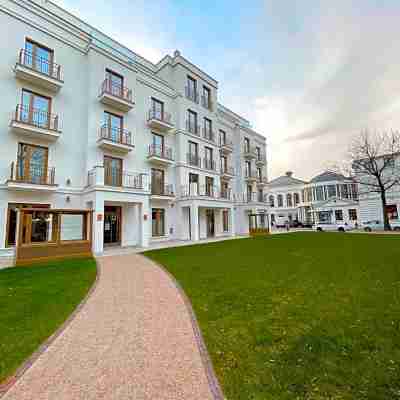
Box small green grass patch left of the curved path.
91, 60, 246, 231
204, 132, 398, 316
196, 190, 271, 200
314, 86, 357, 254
0, 259, 96, 382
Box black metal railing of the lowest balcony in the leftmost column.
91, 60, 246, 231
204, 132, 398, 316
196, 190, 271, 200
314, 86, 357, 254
10, 157, 56, 185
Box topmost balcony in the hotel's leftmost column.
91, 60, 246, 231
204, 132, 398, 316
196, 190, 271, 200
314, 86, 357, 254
14, 49, 64, 92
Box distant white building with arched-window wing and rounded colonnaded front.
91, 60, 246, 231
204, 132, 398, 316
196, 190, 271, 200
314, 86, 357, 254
267, 171, 359, 226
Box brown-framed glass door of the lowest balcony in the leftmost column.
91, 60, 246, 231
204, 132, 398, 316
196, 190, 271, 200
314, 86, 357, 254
16, 143, 48, 184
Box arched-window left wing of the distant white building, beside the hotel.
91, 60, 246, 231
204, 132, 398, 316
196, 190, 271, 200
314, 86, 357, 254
267, 171, 306, 226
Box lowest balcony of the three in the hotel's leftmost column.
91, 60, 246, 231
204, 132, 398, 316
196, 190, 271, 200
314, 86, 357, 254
6, 158, 58, 192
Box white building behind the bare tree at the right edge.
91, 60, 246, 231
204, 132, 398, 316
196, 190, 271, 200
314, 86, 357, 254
353, 154, 400, 223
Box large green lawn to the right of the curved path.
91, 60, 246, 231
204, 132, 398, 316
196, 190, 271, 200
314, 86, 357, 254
145, 233, 400, 400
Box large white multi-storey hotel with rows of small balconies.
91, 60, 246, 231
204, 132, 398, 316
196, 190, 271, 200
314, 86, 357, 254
0, 0, 267, 256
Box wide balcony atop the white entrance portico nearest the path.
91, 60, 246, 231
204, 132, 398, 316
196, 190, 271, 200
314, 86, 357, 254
87, 166, 149, 191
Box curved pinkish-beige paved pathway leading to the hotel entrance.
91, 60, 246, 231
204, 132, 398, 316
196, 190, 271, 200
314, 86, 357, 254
2, 255, 221, 400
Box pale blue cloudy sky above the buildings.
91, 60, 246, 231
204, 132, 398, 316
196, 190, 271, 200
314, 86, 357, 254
55, 0, 400, 179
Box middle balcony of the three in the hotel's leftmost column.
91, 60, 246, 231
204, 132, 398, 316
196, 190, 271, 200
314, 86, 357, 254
10, 104, 61, 141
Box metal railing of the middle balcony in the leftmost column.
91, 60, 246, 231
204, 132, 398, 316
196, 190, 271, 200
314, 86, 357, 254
13, 104, 60, 132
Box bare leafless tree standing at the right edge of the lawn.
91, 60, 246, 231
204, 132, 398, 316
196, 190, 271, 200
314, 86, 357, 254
348, 130, 400, 230
